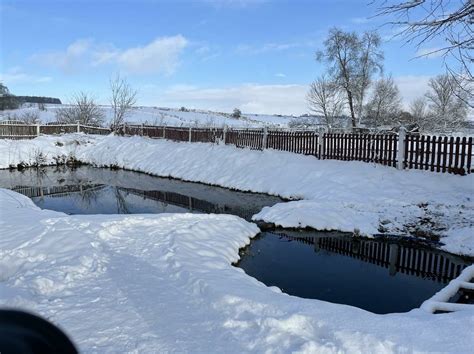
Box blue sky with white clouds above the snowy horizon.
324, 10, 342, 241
0, 0, 452, 115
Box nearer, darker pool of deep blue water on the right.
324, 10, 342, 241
237, 230, 471, 313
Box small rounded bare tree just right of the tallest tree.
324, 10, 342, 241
365, 77, 401, 127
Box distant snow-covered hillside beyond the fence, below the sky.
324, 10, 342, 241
0, 104, 294, 128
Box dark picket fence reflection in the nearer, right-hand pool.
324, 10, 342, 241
275, 233, 468, 283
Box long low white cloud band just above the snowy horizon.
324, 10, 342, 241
159, 84, 308, 115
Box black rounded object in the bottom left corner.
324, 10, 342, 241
0, 310, 77, 354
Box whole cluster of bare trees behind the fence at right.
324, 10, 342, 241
307, 28, 469, 131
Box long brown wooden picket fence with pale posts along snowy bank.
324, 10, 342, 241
0, 122, 474, 175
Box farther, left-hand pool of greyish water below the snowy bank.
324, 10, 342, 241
0, 166, 282, 220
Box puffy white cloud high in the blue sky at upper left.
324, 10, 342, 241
32, 35, 188, 75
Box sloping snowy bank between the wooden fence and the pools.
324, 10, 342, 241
0, 134, 474, 255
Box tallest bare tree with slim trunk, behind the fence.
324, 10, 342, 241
316, 28, 383, 127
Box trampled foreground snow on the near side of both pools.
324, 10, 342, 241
0, 187, 474, 353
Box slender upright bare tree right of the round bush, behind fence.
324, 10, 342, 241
110, 74, 137, 127
